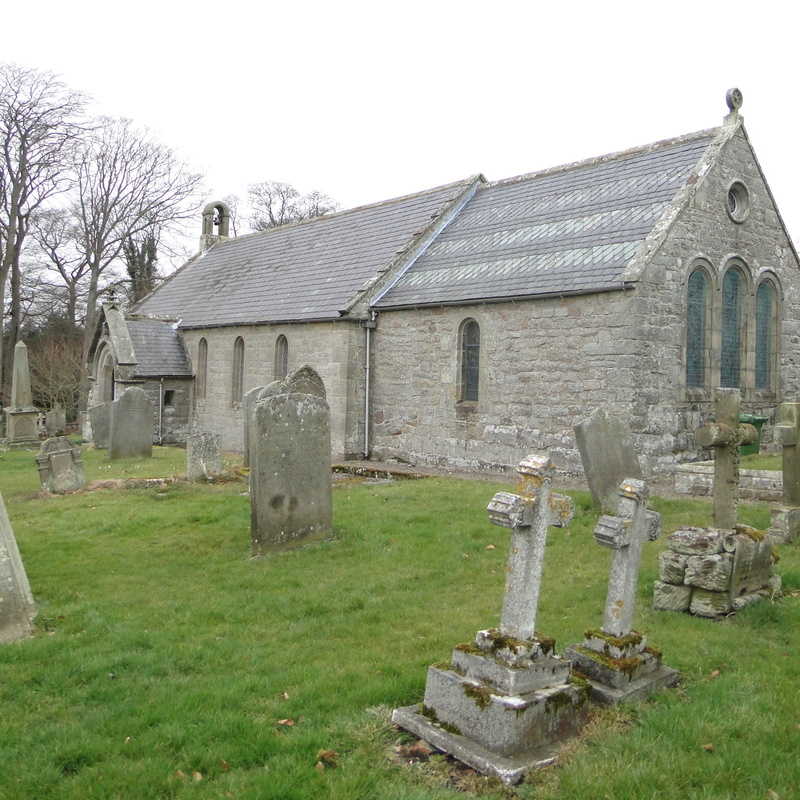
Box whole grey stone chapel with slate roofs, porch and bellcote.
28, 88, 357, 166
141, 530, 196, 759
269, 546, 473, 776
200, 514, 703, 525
89, 89, 800, 472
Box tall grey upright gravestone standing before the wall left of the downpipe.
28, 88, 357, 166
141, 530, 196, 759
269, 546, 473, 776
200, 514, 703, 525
249, 366, 332, 555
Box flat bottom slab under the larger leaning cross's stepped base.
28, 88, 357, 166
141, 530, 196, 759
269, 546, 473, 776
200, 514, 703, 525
392, 703, 559, 786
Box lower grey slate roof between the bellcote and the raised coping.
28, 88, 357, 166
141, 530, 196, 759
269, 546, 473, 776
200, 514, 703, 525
135, 179, 474, 326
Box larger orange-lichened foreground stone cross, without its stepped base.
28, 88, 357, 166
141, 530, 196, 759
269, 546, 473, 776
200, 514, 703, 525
487, 455, 575, 640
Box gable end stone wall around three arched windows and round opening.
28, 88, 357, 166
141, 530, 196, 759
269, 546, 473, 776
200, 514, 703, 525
631, 131, 800, 472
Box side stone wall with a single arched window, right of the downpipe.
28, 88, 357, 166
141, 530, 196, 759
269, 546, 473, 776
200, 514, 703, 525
371, 291, 640, 473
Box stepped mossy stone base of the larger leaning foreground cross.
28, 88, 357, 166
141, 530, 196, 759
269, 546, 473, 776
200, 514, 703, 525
392, 629, 587, 784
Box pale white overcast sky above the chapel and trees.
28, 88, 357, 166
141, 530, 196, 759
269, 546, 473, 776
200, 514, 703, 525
6, 0, 800, 260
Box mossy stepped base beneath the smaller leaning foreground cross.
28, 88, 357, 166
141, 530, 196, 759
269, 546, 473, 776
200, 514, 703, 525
564, 631, 680, 705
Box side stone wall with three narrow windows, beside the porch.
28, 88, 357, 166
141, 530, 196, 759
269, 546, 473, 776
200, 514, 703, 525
183, 322, 364, 458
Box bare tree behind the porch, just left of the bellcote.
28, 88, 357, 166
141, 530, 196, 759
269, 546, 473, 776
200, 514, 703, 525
74, 119, 200, 408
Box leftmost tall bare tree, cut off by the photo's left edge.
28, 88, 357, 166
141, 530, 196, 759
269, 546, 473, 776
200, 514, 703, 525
0, 64, 86, 400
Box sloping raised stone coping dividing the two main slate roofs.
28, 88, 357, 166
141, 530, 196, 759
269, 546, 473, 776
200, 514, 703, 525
346, 173, 486, 316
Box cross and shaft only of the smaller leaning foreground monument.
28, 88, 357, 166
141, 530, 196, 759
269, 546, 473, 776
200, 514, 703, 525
594, 478, 659, 637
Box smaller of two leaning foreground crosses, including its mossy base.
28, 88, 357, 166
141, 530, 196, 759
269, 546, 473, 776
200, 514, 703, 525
565, 479, 680, 704
